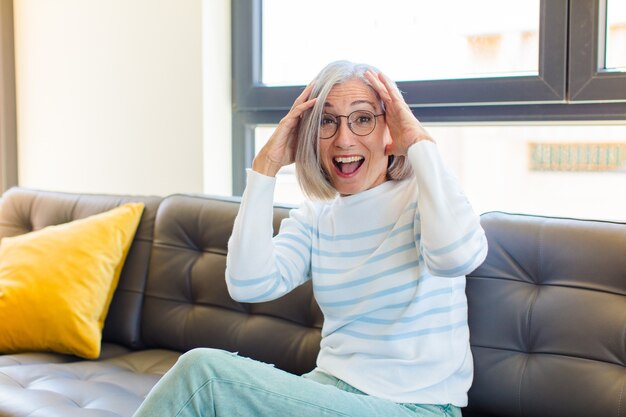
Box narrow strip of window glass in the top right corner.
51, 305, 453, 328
605, 0, 626, 71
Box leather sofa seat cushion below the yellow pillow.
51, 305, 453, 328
0, 349, 180, 417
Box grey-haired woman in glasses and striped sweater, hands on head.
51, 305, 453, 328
137, 61, 487, 417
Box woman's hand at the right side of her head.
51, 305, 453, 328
365, 71, 434, 155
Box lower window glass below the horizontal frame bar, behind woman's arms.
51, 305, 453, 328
256, 124, 626, 221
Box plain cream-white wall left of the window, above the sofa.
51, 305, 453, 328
14, 0, 230, 195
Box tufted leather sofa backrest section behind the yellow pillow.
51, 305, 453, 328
0, 188, 161, 348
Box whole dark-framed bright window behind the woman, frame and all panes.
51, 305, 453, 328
233, 0, 626, 220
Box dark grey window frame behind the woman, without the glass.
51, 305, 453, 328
232, 0, 626, 195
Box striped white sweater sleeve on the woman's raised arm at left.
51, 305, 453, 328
226, 171, 311, 302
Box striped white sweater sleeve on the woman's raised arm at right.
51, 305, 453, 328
408, 141, 487, 277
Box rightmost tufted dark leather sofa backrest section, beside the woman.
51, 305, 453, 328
464, 213, 626, 417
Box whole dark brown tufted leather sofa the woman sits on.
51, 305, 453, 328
0, 188, 626, 417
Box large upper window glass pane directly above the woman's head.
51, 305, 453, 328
262, 0, 540, 86
